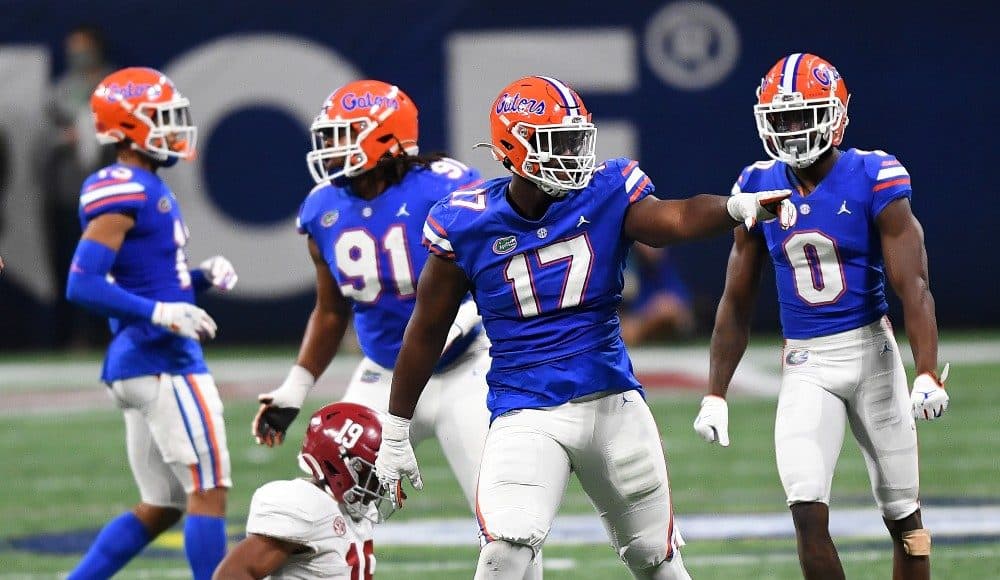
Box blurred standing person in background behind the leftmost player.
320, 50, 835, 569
37, 26, 114, 348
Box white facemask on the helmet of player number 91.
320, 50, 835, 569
306, 114, 378, 184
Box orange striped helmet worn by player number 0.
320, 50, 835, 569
754, 53, 851, 169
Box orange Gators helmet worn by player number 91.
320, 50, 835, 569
306, 80, 419, 183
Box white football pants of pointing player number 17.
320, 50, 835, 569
476, 391, 686, 577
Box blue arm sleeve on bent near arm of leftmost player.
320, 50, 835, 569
66, 240, 156, 320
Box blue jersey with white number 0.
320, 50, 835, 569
733, 149, 911, 339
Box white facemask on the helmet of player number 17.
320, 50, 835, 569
511, 117, 597, 198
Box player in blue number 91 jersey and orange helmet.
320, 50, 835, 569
252, 80, 540, 572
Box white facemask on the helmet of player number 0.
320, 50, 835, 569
754, 87, 847, 169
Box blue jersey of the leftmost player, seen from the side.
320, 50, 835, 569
80, 164, 208, 383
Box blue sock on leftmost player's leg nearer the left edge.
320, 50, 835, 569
67, 512, 152, 580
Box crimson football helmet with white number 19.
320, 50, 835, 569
299, 403, 391, 520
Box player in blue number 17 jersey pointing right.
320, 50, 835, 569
376, 76, 789, 579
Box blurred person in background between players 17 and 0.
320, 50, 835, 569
620, 243, 695, 346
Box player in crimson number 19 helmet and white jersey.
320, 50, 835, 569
214, 403, 390, 580
